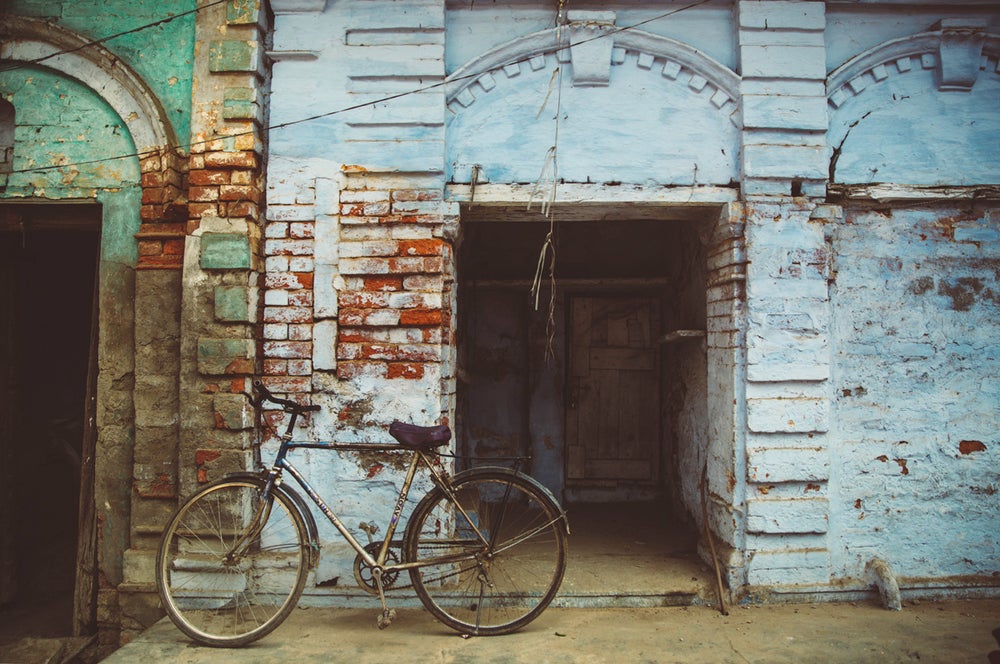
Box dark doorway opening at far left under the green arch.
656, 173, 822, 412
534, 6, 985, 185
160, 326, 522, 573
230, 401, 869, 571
0, 204, 100, 645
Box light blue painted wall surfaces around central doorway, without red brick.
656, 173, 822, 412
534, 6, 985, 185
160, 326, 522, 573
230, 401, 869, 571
269, 0, 1000, 592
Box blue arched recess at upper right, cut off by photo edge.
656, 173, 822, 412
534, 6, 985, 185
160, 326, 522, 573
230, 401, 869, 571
826, 25, 1000, 186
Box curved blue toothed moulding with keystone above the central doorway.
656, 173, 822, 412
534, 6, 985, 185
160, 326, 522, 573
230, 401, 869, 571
445, 22, 740, 115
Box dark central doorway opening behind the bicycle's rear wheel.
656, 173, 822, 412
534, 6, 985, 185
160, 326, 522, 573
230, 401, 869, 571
456, 210, 710, 606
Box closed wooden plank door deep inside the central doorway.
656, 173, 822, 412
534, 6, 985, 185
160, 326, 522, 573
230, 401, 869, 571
566, 296, 660, 485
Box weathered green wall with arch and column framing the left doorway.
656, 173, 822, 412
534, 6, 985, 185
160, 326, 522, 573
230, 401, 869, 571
0, 0, 195, 652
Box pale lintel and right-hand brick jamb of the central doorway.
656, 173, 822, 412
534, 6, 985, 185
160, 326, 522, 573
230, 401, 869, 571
445, 192, 747, 576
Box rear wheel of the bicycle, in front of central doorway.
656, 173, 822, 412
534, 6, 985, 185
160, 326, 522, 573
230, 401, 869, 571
404, 469, 567, 636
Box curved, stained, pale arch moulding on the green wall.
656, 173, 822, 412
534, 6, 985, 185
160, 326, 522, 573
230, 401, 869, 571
0, 14, 178, 156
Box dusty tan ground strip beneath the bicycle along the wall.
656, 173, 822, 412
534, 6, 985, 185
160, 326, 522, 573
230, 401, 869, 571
95, 599, 1000, 664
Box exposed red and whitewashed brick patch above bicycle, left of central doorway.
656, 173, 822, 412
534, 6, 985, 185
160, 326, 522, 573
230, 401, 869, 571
264, 184, 452, 394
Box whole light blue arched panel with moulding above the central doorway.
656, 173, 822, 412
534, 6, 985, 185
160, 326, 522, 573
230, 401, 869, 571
445, 23, 740, 185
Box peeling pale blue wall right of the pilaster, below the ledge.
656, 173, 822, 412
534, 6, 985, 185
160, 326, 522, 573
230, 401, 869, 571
830, 205, 1000, 586
